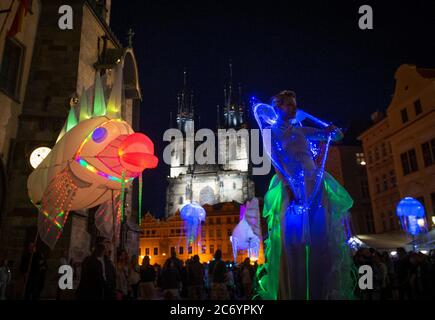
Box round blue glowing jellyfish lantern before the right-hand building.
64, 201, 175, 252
396, 197, 427, 236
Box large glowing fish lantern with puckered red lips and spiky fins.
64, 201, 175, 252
27, 68, 158, 248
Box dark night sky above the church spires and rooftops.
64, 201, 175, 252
111, 0, 435, 216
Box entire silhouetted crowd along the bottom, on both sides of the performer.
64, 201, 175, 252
0, 239, 435, 300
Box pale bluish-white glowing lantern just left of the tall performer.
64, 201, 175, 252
230, 198, 261, 263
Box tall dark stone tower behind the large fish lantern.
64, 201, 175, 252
0, 0, 141, 296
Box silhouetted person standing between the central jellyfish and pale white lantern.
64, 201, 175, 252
209, 249, 229, 300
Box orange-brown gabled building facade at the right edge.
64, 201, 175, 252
360, 65, 435, 232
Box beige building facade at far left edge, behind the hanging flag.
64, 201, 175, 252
0, 0, 41, 230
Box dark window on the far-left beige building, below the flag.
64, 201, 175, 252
0, 38, 24, 98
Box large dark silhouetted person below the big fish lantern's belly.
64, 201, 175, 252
77, 243, 106, 300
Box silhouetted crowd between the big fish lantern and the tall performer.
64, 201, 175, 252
76, 238, 257, 300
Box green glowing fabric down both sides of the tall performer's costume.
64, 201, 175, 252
255, 172, 355, 300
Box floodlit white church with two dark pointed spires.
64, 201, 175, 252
166, 64, 255, 217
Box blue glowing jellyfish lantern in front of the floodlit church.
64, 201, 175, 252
180, 202, 206, 246
